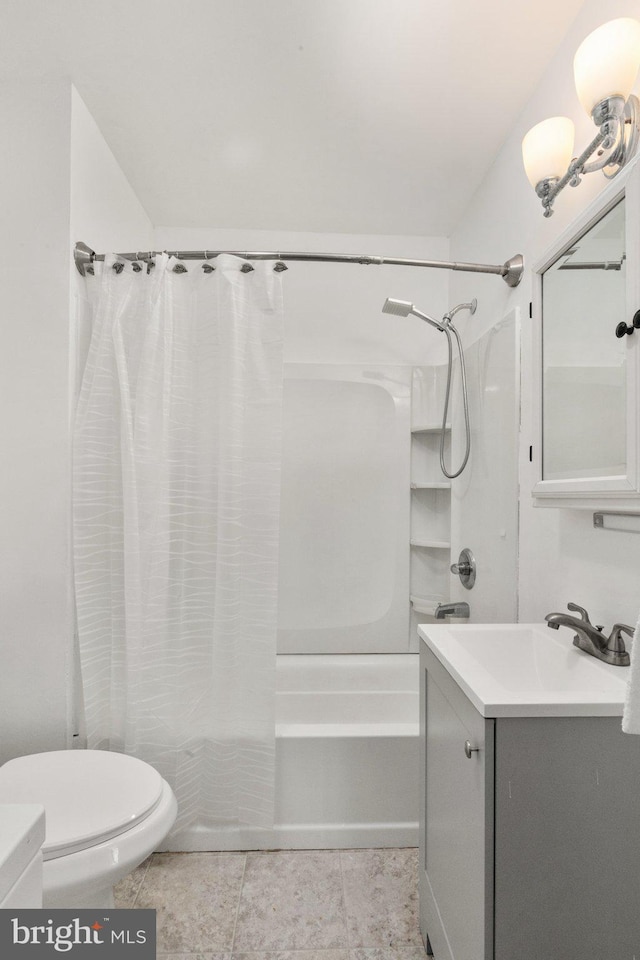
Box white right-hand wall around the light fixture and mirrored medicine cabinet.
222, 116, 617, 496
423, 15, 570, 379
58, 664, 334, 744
451, 0, 640, 625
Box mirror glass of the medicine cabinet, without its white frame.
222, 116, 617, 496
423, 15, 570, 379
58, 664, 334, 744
542, 198, 624, 481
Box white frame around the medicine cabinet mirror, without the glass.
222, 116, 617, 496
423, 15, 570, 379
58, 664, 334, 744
532, 157, 640, 512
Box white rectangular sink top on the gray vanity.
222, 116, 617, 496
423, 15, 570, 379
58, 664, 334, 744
418, 623, 629, 717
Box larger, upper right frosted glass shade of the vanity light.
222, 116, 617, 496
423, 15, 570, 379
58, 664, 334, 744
573, 17, 640, 116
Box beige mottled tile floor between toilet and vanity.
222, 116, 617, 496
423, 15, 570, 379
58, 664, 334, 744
116, 849, 426, 960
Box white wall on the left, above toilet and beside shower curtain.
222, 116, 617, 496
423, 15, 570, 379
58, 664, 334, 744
0, 80, 152, 762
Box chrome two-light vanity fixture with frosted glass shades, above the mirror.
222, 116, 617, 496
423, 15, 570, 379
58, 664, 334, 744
522, 17, 640, 217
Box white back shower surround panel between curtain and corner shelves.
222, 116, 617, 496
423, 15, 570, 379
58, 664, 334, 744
278, 363, 411, 653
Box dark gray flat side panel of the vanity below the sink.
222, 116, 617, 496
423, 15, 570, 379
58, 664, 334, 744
498, 717, 640, 960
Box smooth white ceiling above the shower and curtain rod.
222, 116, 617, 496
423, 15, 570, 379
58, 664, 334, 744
0, 0, 583, 236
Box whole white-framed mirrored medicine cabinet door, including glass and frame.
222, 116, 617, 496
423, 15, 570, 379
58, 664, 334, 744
533, 156, 640, 511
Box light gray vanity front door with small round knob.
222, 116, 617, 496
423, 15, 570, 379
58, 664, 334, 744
423, 665, 493, 960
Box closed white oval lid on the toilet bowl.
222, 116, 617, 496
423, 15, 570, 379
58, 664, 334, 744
0, 750, 163, 860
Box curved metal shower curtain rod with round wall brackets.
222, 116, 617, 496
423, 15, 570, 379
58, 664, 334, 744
73, 243, 524, 287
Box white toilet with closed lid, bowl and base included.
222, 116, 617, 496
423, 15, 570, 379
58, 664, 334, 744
0, 750, 178, 909
